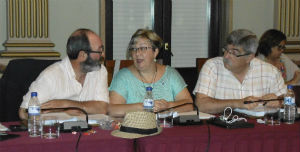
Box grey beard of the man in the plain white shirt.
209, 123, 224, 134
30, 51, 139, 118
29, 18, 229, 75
80, 55, 104, 73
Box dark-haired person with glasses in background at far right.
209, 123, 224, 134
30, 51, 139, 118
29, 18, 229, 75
256, 29, 300, 85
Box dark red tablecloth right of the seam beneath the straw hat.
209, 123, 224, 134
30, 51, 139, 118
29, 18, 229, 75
137, 120, 300, 152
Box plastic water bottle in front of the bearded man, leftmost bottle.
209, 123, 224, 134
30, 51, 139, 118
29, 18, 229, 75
28, 92, 41, 137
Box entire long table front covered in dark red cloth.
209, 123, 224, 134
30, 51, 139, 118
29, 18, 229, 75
0, 119, 300, 152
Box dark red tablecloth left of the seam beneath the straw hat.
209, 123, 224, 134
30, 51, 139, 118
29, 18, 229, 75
0, 122, 134, 152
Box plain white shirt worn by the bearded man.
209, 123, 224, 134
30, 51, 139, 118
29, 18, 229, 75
20, 57, 109, 108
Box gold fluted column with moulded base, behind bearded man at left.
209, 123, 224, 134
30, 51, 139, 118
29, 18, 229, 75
0, 0, 60, 57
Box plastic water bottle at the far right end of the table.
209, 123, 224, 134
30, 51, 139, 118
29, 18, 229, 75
283, 85, 296, 124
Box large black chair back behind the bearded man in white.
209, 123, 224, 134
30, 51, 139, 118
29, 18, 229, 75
0, 59, 59, 122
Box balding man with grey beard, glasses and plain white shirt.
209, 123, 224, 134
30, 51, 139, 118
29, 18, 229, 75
19, 29, 109, 120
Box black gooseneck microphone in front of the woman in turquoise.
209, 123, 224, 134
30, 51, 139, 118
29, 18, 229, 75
155, 102, 202, 125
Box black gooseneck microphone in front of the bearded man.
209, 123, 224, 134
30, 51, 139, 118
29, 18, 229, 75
42, 107, 92, 132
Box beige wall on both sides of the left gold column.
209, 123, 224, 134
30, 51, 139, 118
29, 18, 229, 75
0, 0, 100, 57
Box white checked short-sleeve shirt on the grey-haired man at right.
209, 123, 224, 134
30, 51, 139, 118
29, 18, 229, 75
193, 57, 286, 99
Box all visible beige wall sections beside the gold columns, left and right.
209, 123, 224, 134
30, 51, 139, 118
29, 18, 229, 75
0, 0, 300, 59
